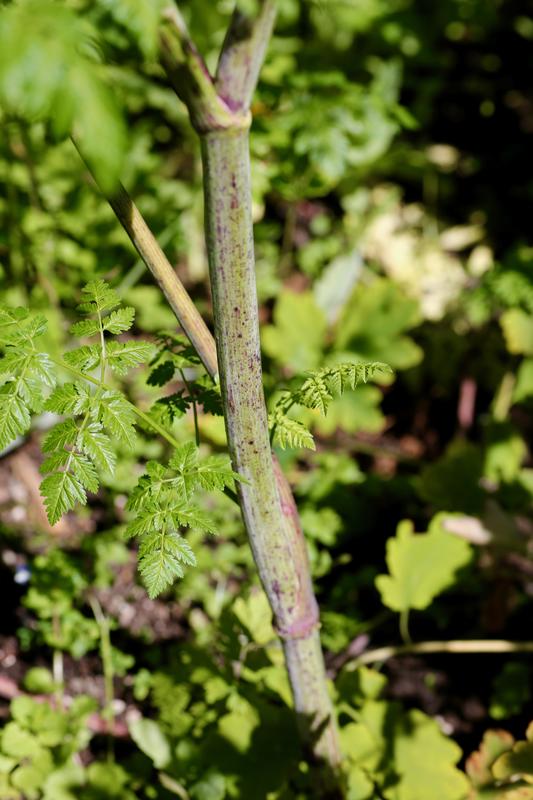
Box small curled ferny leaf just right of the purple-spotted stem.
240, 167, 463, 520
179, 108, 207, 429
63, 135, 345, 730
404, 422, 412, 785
269, 361, 391, 450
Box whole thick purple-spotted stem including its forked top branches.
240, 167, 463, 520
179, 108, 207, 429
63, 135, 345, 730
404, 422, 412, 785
161, 0, 340, 780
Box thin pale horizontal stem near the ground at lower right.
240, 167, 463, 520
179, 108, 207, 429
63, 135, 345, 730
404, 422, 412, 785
345, 639, 533, 671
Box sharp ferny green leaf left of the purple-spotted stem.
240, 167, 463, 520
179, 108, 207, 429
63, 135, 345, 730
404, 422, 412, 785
0, 280, 239, 597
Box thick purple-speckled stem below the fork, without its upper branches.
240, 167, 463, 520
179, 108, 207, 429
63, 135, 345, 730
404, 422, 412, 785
201, 123, 340, 770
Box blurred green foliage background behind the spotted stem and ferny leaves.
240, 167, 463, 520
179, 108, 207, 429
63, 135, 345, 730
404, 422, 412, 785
0, 0, 533, 800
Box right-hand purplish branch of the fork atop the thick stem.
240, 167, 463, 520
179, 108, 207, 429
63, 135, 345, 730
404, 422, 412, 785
215, 0, 277, 113
